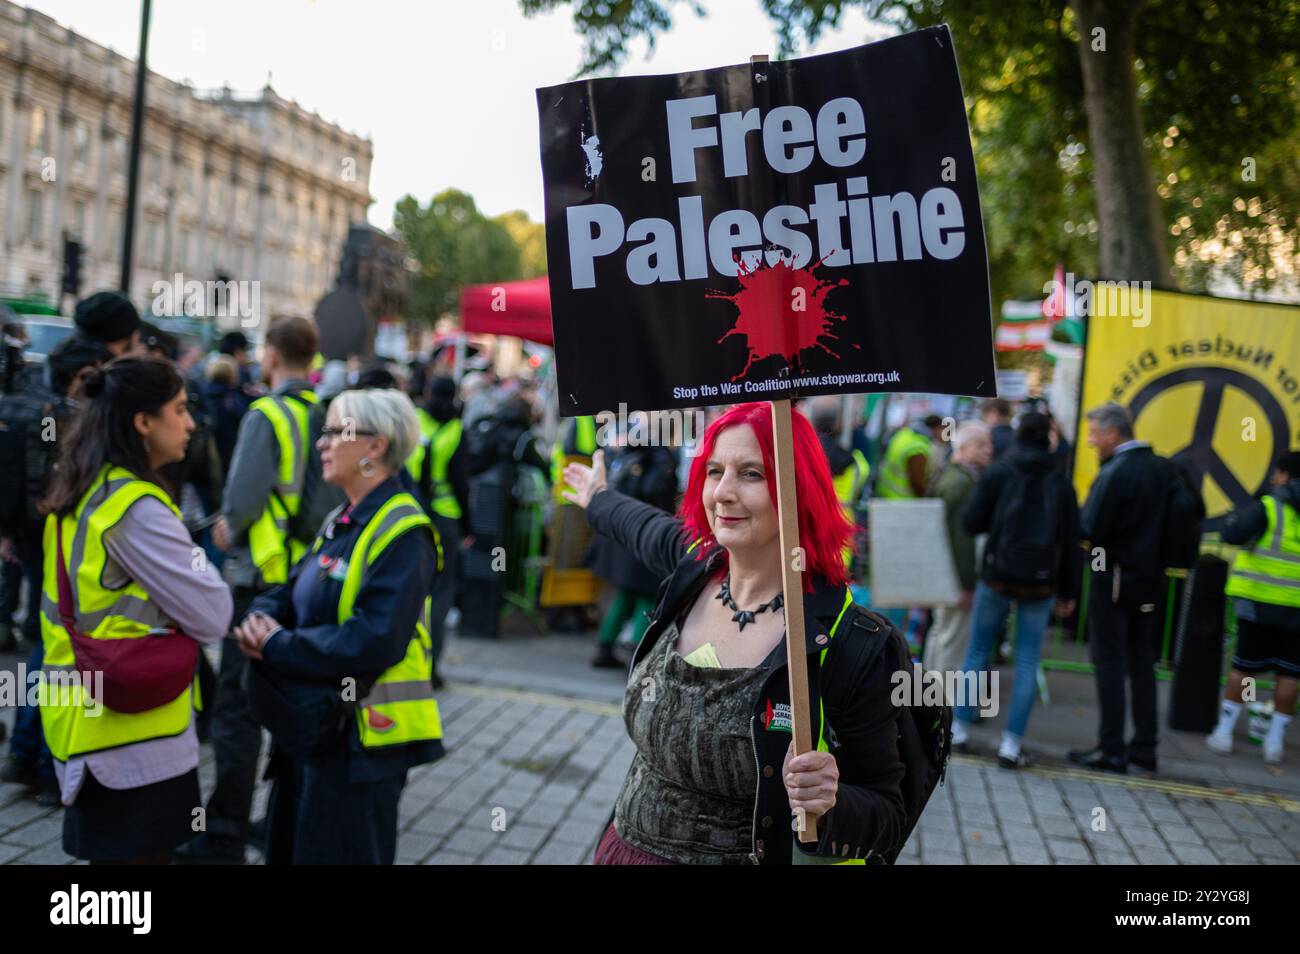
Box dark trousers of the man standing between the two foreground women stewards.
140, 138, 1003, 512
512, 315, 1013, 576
208, 586, 261, 841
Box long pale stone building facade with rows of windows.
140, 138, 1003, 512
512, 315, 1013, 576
0, 0, 373, 330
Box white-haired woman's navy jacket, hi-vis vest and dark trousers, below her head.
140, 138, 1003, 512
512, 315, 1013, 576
250, 462, 443, 864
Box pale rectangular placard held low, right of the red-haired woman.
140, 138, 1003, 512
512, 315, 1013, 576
868, 499, 961, 608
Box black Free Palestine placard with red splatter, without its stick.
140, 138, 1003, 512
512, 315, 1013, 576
537, 27, 995, 415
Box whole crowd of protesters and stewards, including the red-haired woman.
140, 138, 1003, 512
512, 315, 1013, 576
0, 292, 1300, 863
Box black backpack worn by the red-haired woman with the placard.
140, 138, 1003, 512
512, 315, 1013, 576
828, 606, 953, 864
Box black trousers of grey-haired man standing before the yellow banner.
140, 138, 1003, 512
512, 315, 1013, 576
1088, 580, 1157, 755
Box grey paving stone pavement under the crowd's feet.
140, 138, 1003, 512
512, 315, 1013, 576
0, 636, 1300, 864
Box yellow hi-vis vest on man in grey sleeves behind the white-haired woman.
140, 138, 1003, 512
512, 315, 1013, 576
248, 391, 317, 585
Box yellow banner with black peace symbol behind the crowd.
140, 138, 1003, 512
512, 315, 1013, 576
1074, 291, 1300, 529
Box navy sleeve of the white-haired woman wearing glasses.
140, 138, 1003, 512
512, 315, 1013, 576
263, 530, 434, 684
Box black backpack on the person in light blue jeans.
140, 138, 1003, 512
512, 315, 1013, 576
984, 467, 1061, 587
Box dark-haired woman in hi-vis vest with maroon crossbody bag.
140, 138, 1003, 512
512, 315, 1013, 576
33, 355, 233, 864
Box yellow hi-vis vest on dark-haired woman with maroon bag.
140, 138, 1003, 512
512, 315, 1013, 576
40, 465, 195, 762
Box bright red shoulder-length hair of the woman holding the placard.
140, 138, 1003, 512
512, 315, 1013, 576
677, 400, 854, 593
